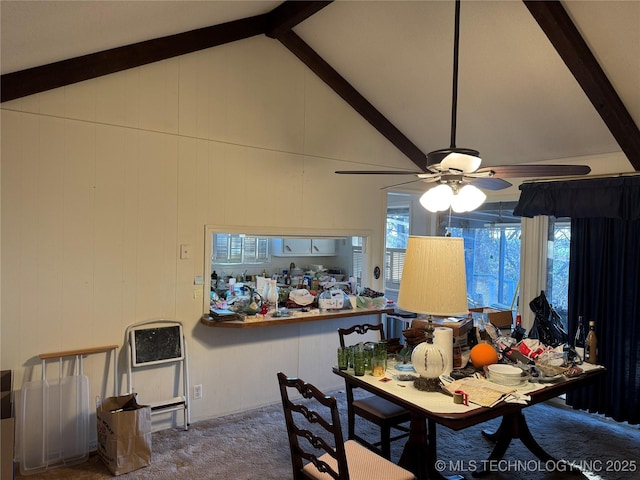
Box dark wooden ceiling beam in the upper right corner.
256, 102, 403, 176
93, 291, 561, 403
523, 0, 640, 171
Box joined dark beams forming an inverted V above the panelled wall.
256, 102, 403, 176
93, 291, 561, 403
0, 0, 427, 171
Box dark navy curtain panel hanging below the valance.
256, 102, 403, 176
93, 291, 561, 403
567, 218, 640, 424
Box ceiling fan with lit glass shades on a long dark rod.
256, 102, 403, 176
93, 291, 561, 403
335, 0, 591, 211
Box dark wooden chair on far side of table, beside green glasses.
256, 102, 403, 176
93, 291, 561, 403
338, 323, 411, 459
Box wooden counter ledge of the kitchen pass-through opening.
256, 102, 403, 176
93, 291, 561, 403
200, 307, 394, 328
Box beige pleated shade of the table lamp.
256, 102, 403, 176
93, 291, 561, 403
398, 236, 469, 317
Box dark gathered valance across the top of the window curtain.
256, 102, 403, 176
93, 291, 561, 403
513, 176, 640, 220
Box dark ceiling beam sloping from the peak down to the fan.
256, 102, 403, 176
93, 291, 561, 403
276, 30, 427, 171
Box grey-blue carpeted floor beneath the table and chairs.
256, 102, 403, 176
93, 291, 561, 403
12, 391, 640, 480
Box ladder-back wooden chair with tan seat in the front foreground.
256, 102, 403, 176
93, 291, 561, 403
278, 372, 415, 480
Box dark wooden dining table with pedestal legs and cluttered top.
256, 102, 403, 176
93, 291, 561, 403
333, 364, 606, 480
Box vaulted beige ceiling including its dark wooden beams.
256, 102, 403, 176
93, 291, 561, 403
0, 0, 640, 176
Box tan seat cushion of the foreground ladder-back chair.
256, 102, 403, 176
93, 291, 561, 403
302, 440, 415, 480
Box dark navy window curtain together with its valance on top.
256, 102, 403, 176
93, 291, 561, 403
514, 177, 640, 424
